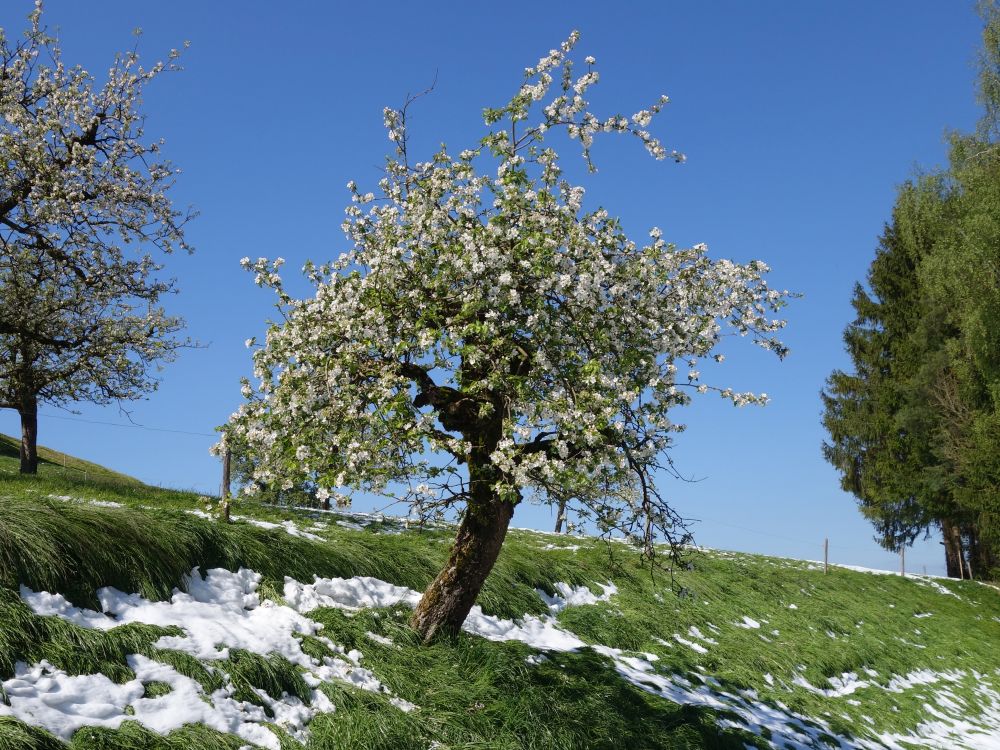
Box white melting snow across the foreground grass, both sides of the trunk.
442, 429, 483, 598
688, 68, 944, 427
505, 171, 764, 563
11, 570, 1000, 750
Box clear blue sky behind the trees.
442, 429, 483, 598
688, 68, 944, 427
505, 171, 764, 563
0, 0, 980, 573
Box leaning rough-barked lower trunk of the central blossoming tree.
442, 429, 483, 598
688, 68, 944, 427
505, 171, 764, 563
410, 495, 514, 643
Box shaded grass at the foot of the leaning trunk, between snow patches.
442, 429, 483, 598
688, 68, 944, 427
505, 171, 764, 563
310, 608, 759, 750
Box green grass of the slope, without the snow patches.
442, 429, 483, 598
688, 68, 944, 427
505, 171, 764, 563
0, 450, 1000, 750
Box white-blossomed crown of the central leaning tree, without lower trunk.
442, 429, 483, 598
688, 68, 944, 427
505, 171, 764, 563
224, 33, 788, 548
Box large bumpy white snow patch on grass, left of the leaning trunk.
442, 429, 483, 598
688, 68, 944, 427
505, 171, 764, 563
19, 568, 414, 750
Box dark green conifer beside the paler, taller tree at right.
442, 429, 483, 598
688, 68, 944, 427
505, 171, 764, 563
822, 191, 958, 575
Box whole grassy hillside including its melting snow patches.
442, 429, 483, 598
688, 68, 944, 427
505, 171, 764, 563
0, 458, 1000, 750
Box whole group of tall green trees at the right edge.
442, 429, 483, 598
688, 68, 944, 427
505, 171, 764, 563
822, 0, 1000, 578
